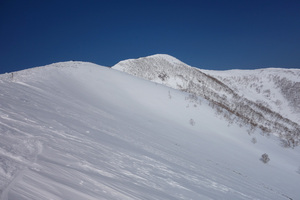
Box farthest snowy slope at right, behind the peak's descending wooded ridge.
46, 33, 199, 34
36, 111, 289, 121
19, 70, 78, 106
201, 68, 300, 124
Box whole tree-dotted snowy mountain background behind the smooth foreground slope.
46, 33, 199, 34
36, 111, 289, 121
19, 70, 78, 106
113, 54, 300, 147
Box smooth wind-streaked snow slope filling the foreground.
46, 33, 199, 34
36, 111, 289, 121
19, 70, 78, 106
0, 62, 300, 200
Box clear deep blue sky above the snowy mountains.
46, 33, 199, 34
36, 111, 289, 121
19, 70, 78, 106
0, 0, 300, 74
